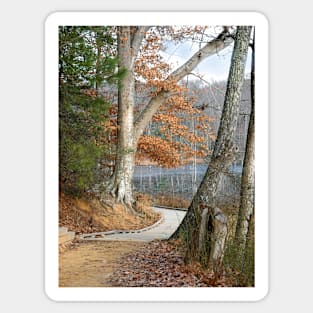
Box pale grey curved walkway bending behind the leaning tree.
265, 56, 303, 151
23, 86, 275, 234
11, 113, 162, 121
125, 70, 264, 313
81, 207, 186, 241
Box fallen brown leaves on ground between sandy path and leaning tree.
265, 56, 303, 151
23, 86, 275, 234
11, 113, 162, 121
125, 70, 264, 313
109, 241, 232, 287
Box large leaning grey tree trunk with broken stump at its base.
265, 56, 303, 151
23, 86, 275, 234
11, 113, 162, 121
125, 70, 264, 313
174, 26, 251, 266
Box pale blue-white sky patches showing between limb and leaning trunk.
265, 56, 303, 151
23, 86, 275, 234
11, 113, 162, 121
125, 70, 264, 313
162, 37, 251, 82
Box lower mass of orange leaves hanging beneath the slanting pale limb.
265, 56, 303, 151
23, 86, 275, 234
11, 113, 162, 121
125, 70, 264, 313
136, 85, 215, 168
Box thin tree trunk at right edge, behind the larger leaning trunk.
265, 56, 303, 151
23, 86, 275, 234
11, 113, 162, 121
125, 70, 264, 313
235, 31, 255, 261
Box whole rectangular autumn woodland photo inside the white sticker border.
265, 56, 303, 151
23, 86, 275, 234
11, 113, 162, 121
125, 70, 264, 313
58, 25, 257, 287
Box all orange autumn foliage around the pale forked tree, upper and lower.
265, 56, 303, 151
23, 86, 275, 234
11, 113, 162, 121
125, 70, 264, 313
105, 27, 214, 167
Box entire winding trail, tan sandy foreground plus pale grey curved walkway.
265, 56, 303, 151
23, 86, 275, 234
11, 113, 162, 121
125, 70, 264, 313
59, 208, 186, 287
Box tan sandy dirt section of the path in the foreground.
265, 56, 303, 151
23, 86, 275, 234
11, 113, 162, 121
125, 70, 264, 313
59, 241, 144, 287
